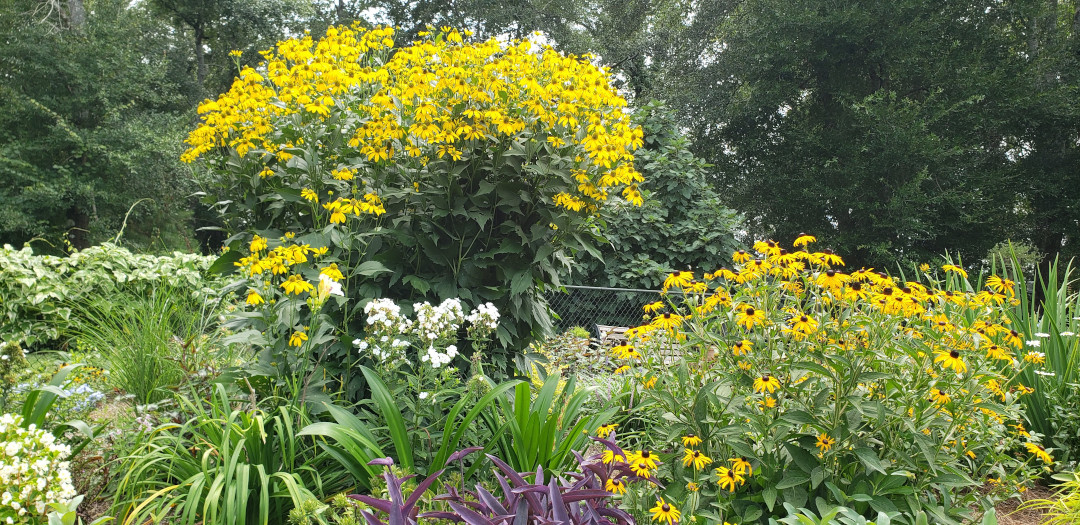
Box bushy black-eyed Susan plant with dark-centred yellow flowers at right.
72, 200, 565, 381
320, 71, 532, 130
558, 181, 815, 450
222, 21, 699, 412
612, 235, 1054, 524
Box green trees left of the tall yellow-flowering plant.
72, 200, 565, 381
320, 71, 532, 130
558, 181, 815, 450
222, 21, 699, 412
0, 0, 194, 253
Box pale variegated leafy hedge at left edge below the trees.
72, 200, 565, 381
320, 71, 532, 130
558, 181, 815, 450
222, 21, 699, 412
0, 243, 217, 349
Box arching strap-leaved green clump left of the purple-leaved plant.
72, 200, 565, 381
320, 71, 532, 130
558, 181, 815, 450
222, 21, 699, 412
116, 385, 349, 525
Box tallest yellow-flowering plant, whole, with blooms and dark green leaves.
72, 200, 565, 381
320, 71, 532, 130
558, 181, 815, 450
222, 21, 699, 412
184, 25, 643, 380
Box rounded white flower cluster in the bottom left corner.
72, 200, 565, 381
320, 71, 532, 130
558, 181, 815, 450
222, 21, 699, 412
0, 414, 77, 523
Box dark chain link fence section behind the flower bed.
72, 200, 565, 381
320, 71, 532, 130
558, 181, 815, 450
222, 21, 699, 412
548, 286, 660, 338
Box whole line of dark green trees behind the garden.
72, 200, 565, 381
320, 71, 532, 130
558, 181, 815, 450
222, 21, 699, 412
0, 0, 1080, 285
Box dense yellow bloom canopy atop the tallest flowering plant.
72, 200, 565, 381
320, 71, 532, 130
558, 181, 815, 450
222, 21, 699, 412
181, 24, 643, 211
